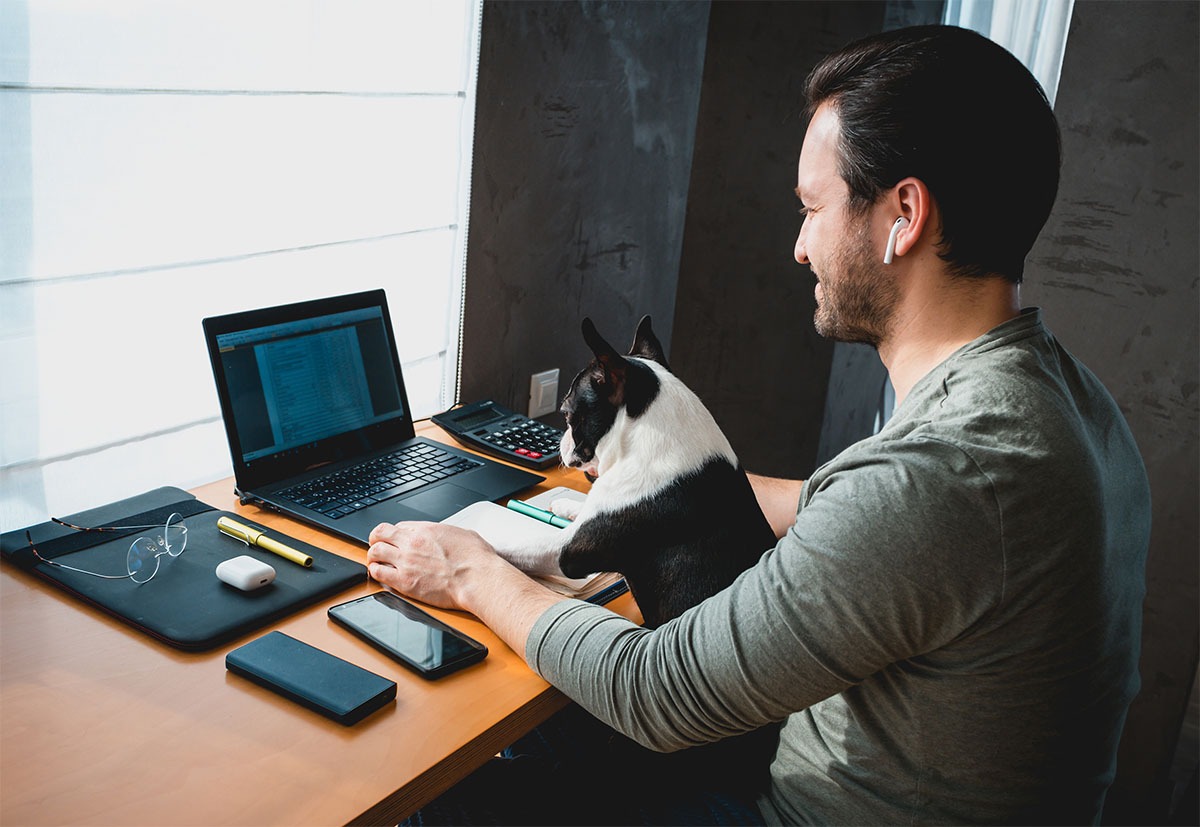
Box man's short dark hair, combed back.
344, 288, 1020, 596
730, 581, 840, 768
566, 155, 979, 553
804, 25, 1061, 283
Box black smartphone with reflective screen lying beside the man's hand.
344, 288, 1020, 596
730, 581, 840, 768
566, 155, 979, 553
329, 592, 487, 679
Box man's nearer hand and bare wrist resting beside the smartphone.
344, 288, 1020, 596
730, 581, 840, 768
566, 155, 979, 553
367, 522, 564, 657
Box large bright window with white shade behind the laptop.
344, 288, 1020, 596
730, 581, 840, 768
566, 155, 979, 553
0, 0, 481, 531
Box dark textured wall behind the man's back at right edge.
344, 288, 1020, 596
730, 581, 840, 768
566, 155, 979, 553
1022, 2, 1200, 823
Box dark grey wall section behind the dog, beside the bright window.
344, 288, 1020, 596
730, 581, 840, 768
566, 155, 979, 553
461, 2, 708, 412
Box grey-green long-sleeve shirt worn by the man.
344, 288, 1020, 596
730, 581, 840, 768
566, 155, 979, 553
526, 310, 1150, 823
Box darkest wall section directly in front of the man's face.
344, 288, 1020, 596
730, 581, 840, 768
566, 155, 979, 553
672, 1, 886, 477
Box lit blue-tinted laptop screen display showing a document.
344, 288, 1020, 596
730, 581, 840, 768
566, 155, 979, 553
217, 307, 404, 462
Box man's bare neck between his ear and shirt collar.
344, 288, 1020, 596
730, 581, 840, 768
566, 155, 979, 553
880, 277, 1021, 406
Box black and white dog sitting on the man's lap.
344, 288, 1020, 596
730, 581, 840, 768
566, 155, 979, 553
498, 316, 775, 628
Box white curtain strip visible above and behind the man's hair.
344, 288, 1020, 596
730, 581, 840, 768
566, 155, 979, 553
942, 0, 1075, 106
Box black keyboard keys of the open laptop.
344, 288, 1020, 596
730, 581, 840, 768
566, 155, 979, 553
281, 443, 484, 520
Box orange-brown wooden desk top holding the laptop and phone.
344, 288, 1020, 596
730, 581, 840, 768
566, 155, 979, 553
0, 423, 638, 825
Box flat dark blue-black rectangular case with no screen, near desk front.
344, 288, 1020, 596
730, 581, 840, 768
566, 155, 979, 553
226, 631, 396, 726
